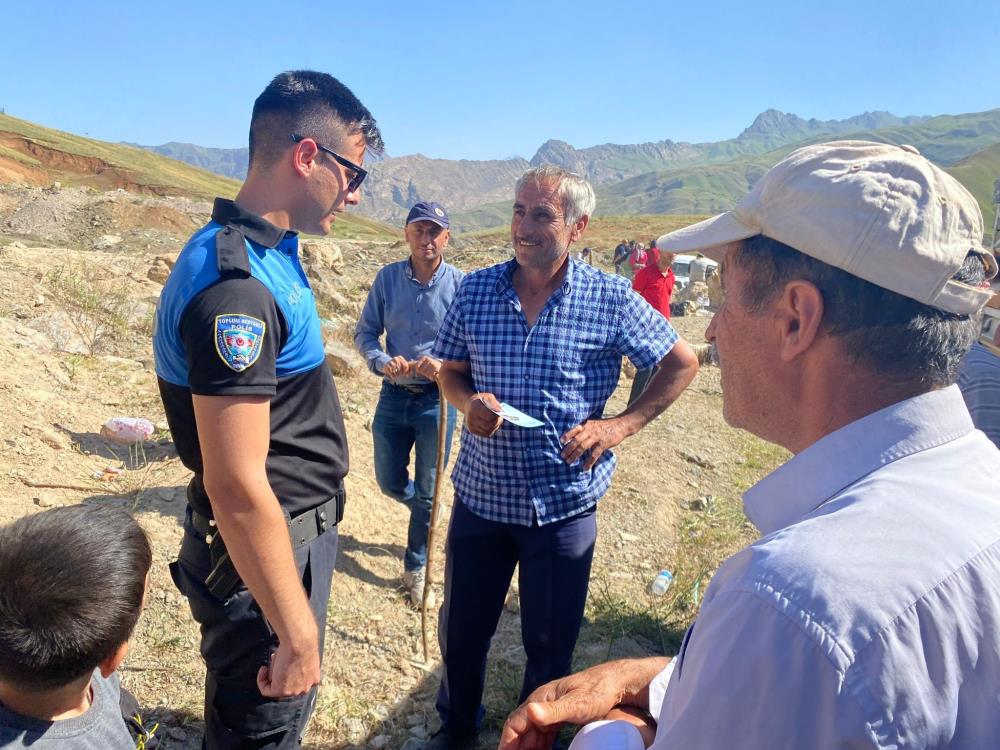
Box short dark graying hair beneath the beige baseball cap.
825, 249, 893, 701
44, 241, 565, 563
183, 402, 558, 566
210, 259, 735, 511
723, 235, 986, 387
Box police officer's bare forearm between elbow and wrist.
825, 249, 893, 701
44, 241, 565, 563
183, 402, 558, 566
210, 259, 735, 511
203, 478, 318, 646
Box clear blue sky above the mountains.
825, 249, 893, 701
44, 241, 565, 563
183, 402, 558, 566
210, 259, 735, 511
0, 0, 1000, 159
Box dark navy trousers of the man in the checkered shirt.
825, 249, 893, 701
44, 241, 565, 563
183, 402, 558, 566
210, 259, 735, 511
437, 498, 597, 736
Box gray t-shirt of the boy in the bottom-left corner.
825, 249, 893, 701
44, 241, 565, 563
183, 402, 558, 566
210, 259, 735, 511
0, 670, 135, 750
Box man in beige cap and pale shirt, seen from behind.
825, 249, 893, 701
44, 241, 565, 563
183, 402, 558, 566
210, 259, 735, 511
500, 141, 1000, 750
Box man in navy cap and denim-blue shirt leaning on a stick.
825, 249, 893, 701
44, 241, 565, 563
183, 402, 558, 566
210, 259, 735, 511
354, 202, 465, 607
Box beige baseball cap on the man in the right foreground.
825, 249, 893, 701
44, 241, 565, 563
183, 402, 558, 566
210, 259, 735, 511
656, 141, 997, 315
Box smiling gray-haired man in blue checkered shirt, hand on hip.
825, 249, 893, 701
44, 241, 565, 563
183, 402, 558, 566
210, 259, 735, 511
427, 166, 698, 749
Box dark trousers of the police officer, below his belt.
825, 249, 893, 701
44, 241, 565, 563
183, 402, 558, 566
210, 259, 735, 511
170, 510, 337, 750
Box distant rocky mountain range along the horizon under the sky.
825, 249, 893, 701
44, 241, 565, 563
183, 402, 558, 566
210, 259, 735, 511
137, 109, 1000, 231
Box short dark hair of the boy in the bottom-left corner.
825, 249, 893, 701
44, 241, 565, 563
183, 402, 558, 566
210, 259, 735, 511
0, 505, 152, 692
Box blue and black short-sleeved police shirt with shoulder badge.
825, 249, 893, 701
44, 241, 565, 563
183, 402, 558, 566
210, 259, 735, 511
153, 199, 348, 517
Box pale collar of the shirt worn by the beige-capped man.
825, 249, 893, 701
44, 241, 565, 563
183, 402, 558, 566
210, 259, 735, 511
743, 385, 973, 534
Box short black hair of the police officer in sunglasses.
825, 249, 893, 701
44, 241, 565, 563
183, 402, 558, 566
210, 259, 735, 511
250, 70, 384, 166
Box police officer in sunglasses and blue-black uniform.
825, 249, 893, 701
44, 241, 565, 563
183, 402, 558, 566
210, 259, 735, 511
153, 71, 382, 750
